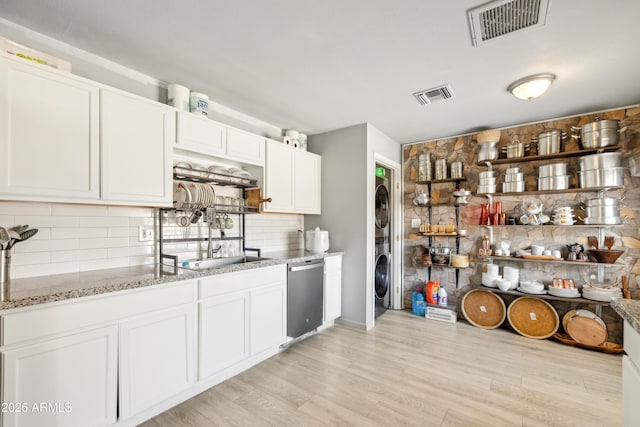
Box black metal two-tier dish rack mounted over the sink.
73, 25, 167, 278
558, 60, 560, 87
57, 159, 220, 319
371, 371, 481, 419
158, 165, 260, 272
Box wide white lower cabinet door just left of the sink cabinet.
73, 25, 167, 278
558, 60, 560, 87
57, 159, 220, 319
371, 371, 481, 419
119, 304, 196, 418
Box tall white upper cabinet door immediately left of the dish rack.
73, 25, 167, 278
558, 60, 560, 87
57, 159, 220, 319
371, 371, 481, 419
100, 89, 175, 206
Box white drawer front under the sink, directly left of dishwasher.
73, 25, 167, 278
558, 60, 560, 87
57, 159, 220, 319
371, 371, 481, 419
198, 264, 287, 299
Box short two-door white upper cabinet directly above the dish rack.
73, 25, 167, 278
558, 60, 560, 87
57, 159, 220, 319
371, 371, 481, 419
176, 111, 265, 166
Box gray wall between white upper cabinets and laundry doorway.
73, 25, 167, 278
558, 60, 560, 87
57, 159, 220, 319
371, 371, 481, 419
305, 123, 402, 328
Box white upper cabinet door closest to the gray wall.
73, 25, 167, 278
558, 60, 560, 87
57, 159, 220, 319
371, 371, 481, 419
293, 150, 321, 214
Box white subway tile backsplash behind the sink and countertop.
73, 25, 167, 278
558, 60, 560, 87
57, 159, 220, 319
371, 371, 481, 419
0, 200, 304, 278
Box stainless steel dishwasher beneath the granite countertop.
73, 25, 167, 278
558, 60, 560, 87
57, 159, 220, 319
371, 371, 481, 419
287, 259, 324, 338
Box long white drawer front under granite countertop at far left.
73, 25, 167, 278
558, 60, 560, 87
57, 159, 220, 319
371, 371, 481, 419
0, 281, 196, 346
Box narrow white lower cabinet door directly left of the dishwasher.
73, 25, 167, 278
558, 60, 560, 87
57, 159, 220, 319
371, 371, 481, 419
250, 283, 287, 355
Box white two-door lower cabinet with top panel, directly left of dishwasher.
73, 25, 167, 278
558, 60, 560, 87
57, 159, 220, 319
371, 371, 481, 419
198, 264, 287, 380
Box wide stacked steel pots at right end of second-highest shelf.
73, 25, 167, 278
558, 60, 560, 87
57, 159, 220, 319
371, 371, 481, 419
578, 153, 625, 188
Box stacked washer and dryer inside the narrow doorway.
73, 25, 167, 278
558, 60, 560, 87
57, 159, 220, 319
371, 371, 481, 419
374, 165, 392, 317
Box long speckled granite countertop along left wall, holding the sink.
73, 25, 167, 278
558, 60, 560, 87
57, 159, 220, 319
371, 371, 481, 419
0, 249, 342, 311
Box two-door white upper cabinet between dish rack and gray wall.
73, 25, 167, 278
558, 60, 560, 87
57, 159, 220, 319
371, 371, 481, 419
264, 141, 321, 214
